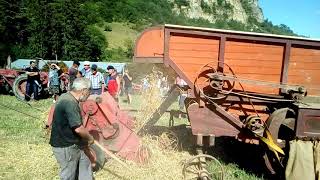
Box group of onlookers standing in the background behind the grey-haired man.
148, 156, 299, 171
25, 61, 132, 103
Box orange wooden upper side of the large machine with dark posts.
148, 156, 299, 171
134, 26, 320, 96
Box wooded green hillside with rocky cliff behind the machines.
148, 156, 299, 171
0, 0, 296, 66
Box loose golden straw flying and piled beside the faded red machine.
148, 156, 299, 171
95, 73, 190, 180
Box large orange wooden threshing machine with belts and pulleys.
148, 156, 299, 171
134, 25, 320, 177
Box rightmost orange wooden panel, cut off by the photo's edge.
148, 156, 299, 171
288, 47, 320, 96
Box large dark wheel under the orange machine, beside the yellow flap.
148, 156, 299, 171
263, 108, 296, 176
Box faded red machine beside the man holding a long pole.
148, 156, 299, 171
47, 92, 149, 171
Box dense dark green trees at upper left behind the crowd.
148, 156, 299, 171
0, 0, 107, 65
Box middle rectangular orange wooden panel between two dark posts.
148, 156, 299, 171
224, 40, 284, 94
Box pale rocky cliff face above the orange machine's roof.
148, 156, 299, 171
169, 0, 264, 24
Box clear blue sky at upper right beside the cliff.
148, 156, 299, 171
259, 0, 320, 39
